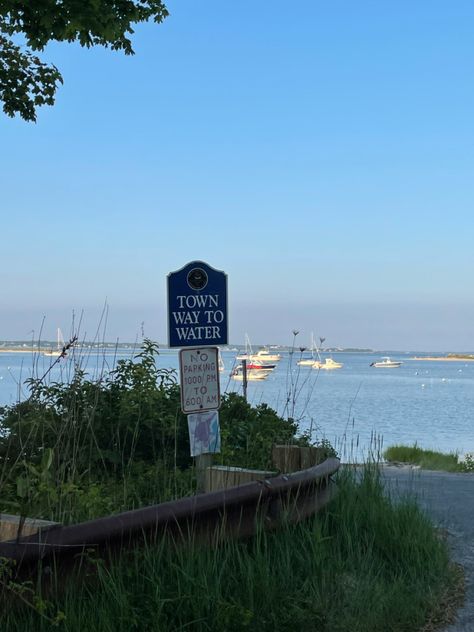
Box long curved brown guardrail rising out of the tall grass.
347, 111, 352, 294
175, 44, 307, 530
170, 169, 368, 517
0, 458, 339, 570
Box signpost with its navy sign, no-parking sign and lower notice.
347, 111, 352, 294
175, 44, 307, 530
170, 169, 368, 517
167, 261, 228, 491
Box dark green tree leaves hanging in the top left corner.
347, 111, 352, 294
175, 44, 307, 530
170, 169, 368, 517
0, 0, 168, 121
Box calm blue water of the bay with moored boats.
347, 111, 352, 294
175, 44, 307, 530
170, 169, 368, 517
0, 350, 474, 459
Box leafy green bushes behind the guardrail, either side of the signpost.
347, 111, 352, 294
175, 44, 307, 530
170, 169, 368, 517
0, 340, 318, 522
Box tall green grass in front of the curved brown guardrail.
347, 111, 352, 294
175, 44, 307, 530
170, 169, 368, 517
0, 466, 458, 632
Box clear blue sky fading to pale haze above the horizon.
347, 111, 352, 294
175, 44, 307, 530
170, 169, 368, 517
0, 0, 474, 350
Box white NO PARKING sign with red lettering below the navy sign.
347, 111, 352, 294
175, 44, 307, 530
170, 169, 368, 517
179, 347, 221, 415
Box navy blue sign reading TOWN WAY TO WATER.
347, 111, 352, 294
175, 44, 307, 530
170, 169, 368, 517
168, 261, 228, 347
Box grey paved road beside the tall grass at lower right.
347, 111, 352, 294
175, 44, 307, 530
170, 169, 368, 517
384, 467, 474, 632
